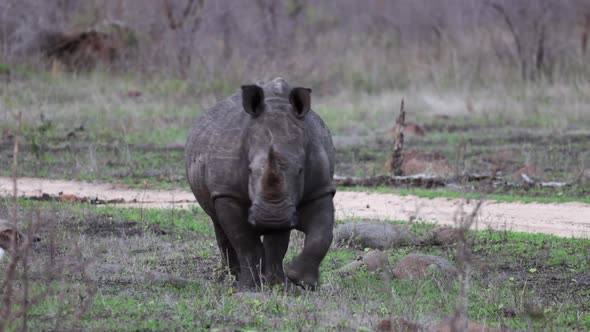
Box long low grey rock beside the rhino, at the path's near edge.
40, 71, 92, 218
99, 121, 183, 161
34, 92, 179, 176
334, 221, 416, 250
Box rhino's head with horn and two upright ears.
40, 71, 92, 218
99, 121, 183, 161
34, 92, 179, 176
242, 85, 311, 229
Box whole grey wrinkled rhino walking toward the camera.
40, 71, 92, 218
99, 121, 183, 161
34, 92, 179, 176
185, 78, 335, 290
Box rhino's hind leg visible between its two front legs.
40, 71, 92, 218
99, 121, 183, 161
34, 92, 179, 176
263, 230, 291, 285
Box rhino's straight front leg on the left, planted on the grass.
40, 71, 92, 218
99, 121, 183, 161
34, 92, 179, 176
215, 197, 264, 291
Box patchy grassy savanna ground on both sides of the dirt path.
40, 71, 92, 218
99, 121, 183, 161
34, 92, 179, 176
0, 71, 590, 330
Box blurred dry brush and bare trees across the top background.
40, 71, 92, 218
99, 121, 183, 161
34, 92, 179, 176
0, 0, 590, 94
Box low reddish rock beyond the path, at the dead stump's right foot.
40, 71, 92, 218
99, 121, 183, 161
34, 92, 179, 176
402, 151, 453, 177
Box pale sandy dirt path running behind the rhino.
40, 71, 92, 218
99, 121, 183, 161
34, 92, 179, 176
0, 177, 590, 238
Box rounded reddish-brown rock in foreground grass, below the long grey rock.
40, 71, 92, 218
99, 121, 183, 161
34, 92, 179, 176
393, 254, 457, 279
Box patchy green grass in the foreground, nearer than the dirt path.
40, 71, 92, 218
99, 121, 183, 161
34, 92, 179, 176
0, 200, 590, 331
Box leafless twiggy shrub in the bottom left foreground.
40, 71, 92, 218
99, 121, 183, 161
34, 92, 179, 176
0, 214, 96, 331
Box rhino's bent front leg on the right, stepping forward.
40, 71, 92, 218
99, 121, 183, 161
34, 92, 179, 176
286, 195, 334, 290
